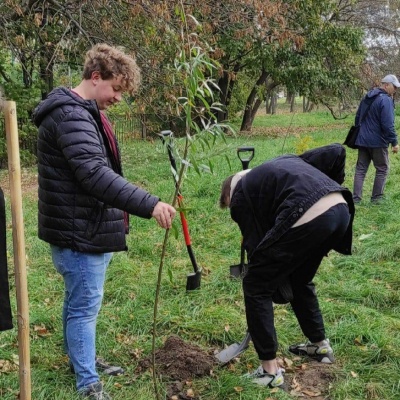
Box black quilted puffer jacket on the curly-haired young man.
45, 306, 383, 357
34, 88, 159, 253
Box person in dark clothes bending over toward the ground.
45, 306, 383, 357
220, 144, 355, 387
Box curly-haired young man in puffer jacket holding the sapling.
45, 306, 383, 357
33, 44, 176, 399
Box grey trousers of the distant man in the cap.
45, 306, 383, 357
353, 147, 389, 202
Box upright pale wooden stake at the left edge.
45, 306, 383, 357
4, 101, 31, 400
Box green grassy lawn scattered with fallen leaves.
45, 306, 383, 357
0, 108, 400, 400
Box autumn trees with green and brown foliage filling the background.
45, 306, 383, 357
0, 0, 399, 138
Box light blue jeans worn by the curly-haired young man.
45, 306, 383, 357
51, 246, 112, 390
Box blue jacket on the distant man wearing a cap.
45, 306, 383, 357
355, 88, 397, 148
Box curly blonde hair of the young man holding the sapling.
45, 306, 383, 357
82, 43, 141, 94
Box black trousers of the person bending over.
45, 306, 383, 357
243, 203, 350, 360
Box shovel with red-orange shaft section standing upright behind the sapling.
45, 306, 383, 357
159, 131, 201, 291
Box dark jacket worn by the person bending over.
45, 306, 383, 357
230, 144, 355, 260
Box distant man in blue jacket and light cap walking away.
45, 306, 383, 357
353, 75, 400, 203
